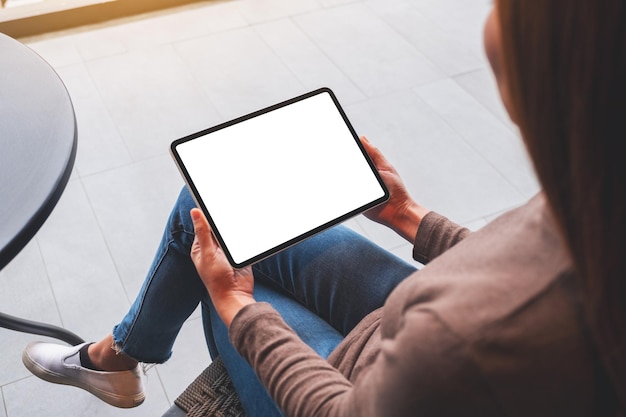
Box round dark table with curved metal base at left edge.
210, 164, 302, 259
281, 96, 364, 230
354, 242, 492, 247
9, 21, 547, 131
0, 33, 82, 344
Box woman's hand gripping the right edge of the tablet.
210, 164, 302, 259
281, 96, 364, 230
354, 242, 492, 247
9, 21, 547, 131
361, 136, 429, 243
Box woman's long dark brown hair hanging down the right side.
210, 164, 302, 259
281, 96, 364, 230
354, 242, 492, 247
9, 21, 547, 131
497, 0, 626, 415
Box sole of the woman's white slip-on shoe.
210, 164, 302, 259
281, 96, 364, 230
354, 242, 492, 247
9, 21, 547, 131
22, 346, 146, 408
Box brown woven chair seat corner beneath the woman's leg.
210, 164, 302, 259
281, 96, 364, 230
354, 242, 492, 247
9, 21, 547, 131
174, 357, 246, 417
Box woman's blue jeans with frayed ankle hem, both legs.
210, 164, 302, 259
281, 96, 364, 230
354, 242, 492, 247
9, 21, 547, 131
113, 188, 415, 417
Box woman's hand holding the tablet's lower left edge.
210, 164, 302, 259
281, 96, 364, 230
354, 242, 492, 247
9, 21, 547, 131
190, 208, 255, 327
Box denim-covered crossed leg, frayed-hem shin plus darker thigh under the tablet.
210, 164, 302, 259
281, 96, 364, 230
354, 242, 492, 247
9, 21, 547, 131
113, 187, 415, 363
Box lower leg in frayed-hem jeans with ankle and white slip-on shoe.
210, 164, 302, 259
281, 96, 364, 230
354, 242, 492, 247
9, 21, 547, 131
22, 186, 206, 407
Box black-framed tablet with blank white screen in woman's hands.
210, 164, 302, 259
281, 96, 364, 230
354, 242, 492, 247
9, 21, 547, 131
170, 88, 389, 268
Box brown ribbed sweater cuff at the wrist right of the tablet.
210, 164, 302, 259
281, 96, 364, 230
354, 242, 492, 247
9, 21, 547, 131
413, 211, 470, 264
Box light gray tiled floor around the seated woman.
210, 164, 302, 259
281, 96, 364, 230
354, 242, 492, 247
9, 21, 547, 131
0, 0, 537, 417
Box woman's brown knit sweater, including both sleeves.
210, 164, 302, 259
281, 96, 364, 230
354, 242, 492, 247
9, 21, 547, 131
230, 195, 598, 417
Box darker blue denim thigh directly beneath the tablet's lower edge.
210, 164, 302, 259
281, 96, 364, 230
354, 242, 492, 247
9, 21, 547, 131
253, 226, 416, 336
